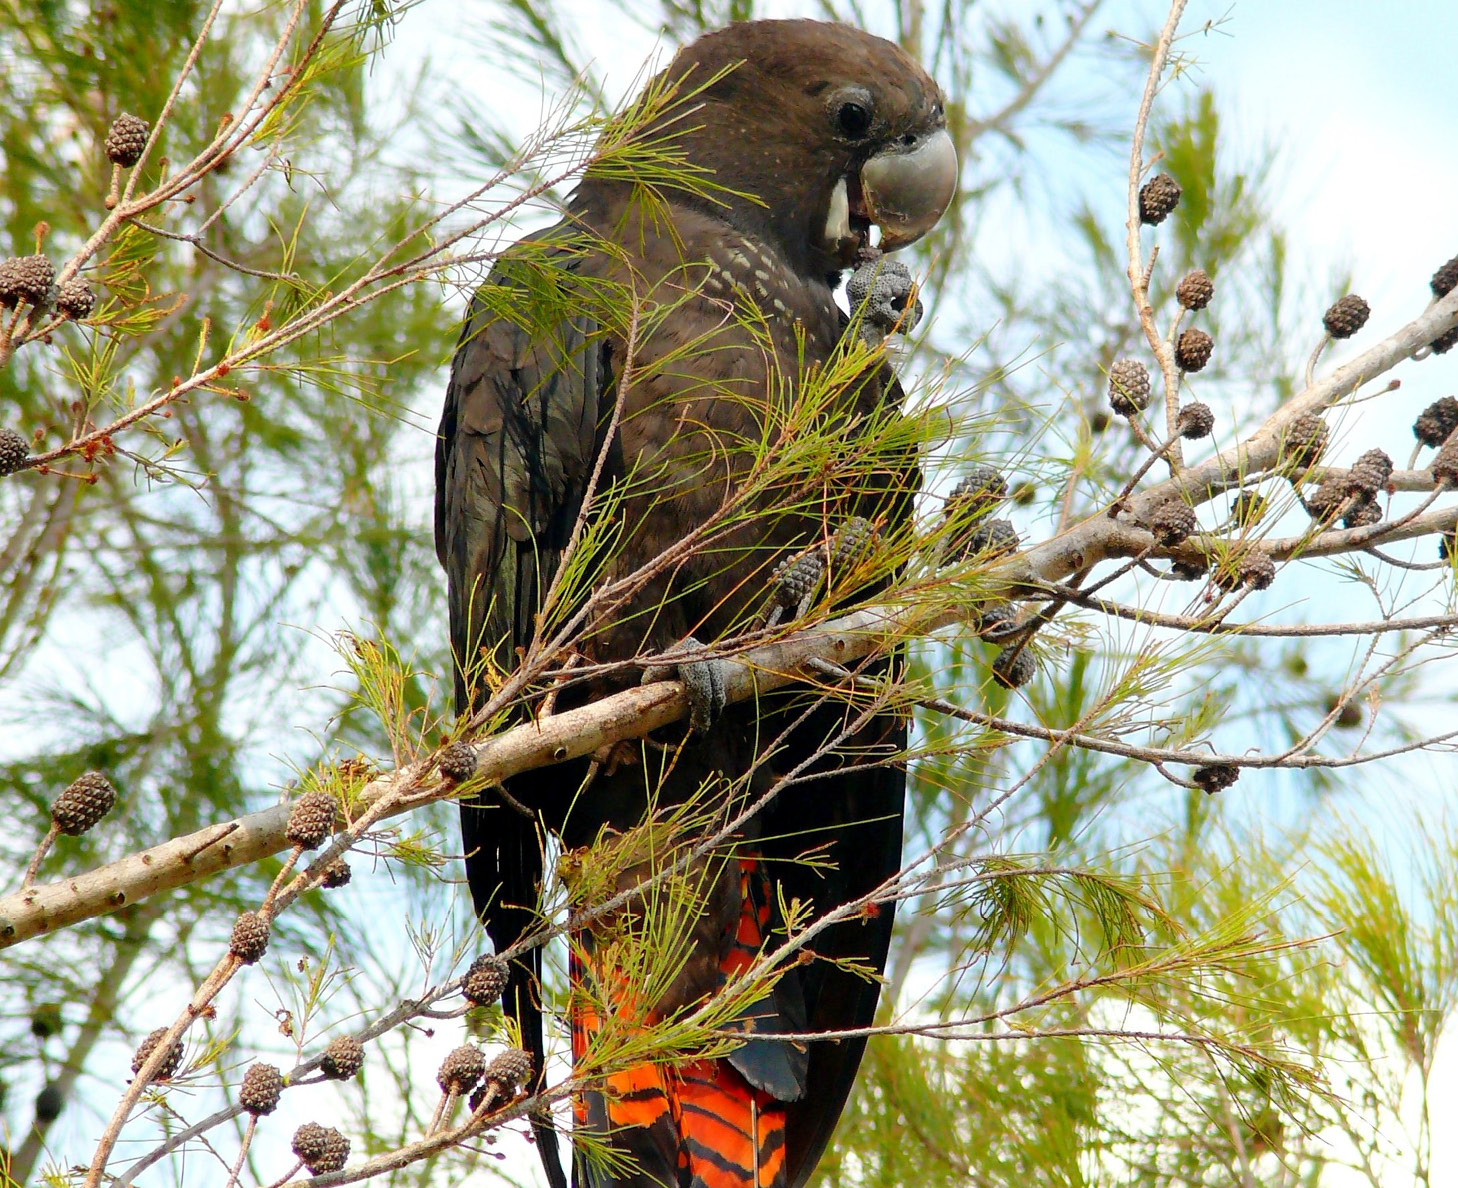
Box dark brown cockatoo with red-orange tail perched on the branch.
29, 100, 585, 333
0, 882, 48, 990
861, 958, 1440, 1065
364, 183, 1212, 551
434, 20, 956, 1188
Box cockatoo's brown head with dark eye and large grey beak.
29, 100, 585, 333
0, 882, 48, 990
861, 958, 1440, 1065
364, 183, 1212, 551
586, 20, 958, 275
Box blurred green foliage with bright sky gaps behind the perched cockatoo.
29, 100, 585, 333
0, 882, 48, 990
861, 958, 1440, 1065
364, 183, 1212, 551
0, 0, 1458, 1188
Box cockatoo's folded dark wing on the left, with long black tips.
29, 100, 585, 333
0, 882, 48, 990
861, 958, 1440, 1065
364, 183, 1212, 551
434, 232, 608, 1188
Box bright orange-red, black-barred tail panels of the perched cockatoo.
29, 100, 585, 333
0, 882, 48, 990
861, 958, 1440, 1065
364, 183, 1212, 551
570, 859, 786, 1188
